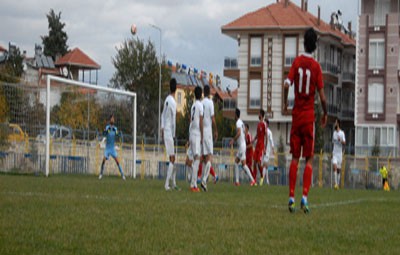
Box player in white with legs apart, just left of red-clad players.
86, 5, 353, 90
229, 108, 256, 186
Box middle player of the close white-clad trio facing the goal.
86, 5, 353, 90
189, 86, 204, 192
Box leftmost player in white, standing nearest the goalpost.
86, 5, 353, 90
161, 79, 180, 191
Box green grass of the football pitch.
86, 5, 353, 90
0, 175, 400, 254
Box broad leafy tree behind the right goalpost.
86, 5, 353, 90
110, 38, 171, 136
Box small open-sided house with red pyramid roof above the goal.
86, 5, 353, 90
55, 48, 101, 84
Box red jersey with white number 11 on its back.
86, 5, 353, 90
288, 54, 324, 123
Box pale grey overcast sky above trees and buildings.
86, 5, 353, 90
0, 0, 359, 86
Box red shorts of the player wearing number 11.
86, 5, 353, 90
290, 122, 314, 158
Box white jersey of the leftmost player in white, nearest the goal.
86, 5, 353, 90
161, 95, 176, 137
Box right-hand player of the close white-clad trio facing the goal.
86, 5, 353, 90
200, 85, 218, 191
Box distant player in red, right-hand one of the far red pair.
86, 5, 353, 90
253, 109, 268, 184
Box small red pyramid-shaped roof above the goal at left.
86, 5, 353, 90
55, 48, 100, 69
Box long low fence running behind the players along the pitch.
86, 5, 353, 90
0, 139, 400, 189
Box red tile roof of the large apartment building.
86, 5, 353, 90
221, 1, 356, 47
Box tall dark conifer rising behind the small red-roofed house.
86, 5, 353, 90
41, 9, 68, 61
